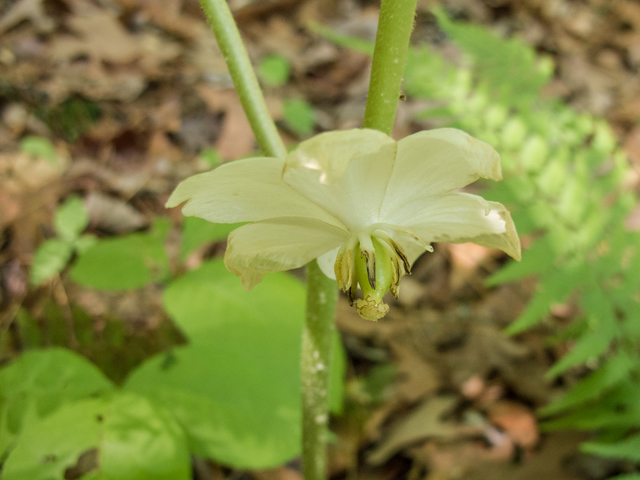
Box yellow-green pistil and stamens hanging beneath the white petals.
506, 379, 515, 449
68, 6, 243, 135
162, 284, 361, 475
335, 226, 422, 321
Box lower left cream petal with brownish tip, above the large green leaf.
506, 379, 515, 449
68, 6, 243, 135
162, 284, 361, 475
224, 217, 349, 291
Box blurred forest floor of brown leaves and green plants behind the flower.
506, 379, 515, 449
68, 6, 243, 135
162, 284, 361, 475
0, 0, 640, 480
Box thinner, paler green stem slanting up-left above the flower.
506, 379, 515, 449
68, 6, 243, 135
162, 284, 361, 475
200, 0, 287, 157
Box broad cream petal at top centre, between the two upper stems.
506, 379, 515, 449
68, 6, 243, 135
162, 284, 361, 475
283, 129, 397, 230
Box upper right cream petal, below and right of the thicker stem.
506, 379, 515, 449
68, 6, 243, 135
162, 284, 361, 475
381, 128, 502, 221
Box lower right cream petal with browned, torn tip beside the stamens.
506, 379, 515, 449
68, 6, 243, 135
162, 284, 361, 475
394, 193, 521, 260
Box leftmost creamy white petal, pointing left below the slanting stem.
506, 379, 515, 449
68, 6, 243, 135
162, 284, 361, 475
166, 158, 342, 227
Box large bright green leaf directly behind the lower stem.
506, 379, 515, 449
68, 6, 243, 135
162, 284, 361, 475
126, 260, 344, 468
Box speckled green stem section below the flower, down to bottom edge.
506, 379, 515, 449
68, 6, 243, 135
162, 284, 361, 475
301, 260, 338, 480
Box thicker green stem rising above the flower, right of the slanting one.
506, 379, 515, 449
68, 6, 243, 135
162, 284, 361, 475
362, 0, 417, 135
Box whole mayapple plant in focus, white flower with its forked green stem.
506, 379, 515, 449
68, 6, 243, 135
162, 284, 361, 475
188, 0, 520, 480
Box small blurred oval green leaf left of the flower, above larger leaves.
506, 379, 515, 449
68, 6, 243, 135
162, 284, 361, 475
71, 233, 169, 290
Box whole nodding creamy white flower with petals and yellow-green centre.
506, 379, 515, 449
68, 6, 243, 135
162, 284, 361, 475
167, 128, 520, 320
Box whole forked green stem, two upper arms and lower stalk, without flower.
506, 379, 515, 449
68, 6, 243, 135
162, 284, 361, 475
200, 0, 417, 480
